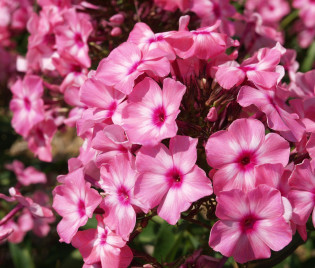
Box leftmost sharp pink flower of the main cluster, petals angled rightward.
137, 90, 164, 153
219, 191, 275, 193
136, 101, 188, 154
53, 168, 102, 243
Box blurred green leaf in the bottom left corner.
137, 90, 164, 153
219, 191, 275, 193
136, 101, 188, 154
9, 243, 35, 268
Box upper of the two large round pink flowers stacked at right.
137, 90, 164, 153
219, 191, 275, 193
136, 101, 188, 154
206, 119, 290, 193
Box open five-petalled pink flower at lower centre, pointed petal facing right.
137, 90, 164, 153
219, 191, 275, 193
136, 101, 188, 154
135, 136, 212, 224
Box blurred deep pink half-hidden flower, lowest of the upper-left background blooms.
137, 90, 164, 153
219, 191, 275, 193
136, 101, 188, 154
26, 118, 57, 162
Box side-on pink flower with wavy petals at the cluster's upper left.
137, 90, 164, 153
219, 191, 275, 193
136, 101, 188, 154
95, 42, 170, 95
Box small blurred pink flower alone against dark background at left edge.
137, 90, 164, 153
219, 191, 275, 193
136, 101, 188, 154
6, 160, 47, 186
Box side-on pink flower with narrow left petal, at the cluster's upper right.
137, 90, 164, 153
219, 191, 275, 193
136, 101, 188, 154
215, 43, 285, 89
